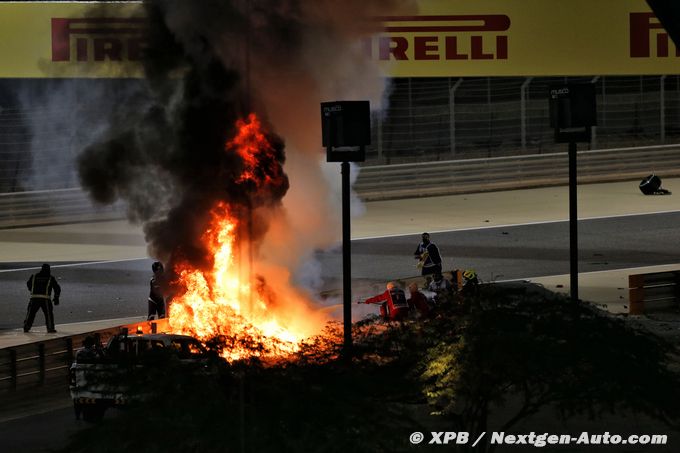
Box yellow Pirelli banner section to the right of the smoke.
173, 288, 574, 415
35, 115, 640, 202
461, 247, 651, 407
378, 0, 680, 77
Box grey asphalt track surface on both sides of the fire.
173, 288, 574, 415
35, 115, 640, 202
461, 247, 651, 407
0, 212, 680, 330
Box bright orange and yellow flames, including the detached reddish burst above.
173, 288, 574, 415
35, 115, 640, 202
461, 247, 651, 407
168, 114, 323, 360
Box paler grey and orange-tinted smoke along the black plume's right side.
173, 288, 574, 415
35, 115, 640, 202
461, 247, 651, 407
240, 0, 414, 294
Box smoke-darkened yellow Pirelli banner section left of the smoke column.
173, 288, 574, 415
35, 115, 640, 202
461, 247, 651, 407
0, 2, 145, 78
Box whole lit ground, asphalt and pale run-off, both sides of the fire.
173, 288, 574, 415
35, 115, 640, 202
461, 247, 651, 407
0, 179, 680, 332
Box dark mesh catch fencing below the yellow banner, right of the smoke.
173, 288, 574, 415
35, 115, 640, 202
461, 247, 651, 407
367, 75, 680, 163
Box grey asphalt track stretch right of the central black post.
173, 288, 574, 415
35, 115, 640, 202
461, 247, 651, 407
352, 212, 680, 281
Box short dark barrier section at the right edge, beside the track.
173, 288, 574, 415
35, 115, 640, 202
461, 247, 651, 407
628, 271, 680, 315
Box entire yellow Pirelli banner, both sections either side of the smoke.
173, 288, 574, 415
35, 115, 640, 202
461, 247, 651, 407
0, 0, 680, 78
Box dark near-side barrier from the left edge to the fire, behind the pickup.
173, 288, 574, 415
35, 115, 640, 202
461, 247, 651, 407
0, 319, 167, 401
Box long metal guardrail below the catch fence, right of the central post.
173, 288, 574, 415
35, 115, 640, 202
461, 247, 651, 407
354, 144, 680, 201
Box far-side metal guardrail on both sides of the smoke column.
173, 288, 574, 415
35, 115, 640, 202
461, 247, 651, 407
0, 144, 680, 224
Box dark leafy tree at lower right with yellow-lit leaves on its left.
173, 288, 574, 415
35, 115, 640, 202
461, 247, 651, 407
422, 288, 680, 432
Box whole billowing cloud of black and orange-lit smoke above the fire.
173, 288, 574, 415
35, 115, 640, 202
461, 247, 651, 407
78, 0, 415, 288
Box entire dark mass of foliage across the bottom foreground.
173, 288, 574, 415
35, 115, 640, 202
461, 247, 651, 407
62, 289, 680, 453
